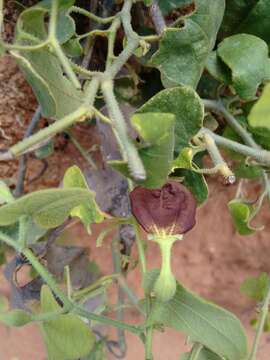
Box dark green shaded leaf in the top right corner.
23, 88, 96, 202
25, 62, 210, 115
237, 0, 270, 45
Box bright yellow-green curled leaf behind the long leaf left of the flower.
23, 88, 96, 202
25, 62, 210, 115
63, 166, 104, 232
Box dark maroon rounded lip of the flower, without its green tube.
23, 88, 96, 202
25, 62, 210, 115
130, 181, 196, 235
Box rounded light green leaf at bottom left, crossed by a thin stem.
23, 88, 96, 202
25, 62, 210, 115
41, 286, 95, 360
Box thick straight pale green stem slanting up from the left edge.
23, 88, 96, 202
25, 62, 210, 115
10, 106, 89, 157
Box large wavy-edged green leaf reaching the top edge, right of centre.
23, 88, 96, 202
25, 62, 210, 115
150, 0, 225, 88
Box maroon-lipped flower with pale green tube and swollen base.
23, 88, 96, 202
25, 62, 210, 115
130, 181, 196, 301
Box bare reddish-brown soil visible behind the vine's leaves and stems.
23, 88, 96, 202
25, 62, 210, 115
0, 57, 270, 360
